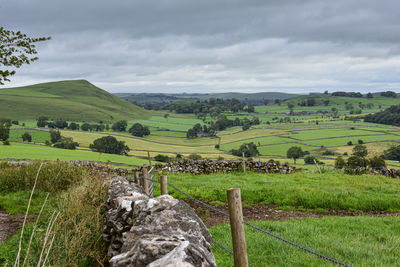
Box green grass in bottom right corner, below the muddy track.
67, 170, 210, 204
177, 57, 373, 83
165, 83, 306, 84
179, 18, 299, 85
210, 216, 400, 267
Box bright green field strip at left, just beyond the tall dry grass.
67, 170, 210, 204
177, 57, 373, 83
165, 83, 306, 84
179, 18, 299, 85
0, 143, 148, 165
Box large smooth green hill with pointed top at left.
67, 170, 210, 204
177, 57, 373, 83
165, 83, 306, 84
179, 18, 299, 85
0, 80, 150, 121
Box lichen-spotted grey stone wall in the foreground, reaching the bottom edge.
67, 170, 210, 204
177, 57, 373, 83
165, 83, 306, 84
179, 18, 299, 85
103, 176, 216, 267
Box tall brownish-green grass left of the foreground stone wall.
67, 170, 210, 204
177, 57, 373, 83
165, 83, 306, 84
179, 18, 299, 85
0, 162, 107, 266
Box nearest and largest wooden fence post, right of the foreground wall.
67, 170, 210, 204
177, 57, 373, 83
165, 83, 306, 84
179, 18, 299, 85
226, 188, 249, 267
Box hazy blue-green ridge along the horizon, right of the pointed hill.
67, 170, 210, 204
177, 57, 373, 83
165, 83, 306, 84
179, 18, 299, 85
115, 92, 299, 105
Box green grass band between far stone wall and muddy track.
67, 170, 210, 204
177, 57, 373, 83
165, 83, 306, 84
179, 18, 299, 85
164, 172, 400, 211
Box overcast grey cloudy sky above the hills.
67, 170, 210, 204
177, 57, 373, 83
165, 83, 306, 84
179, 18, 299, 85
0, 0, 400, 93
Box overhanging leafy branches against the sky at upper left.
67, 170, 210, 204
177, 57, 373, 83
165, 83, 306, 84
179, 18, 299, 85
0, 27, 50, 85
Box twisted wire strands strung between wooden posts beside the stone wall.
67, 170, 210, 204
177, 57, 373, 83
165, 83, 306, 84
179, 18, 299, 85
140, 175, 351, 267
